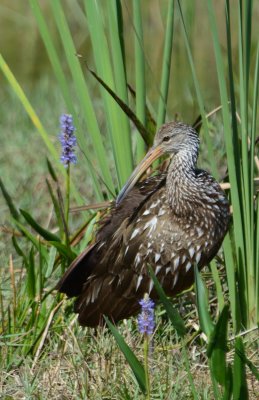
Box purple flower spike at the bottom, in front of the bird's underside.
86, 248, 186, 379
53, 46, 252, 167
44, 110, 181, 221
138, 294, 155, 335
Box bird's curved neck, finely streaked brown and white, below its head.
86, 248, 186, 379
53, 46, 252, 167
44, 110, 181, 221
166, 150, 199, 217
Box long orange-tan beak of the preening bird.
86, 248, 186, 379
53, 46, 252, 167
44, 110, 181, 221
116, 145, 164, 205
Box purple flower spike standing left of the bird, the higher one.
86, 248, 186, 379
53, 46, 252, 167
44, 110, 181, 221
59, 114, 77, 167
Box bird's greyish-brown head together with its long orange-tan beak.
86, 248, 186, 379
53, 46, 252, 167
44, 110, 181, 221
116, 122, 199, 204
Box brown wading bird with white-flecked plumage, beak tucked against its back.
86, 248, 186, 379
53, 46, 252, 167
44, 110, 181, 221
57, 121, 230, 327
